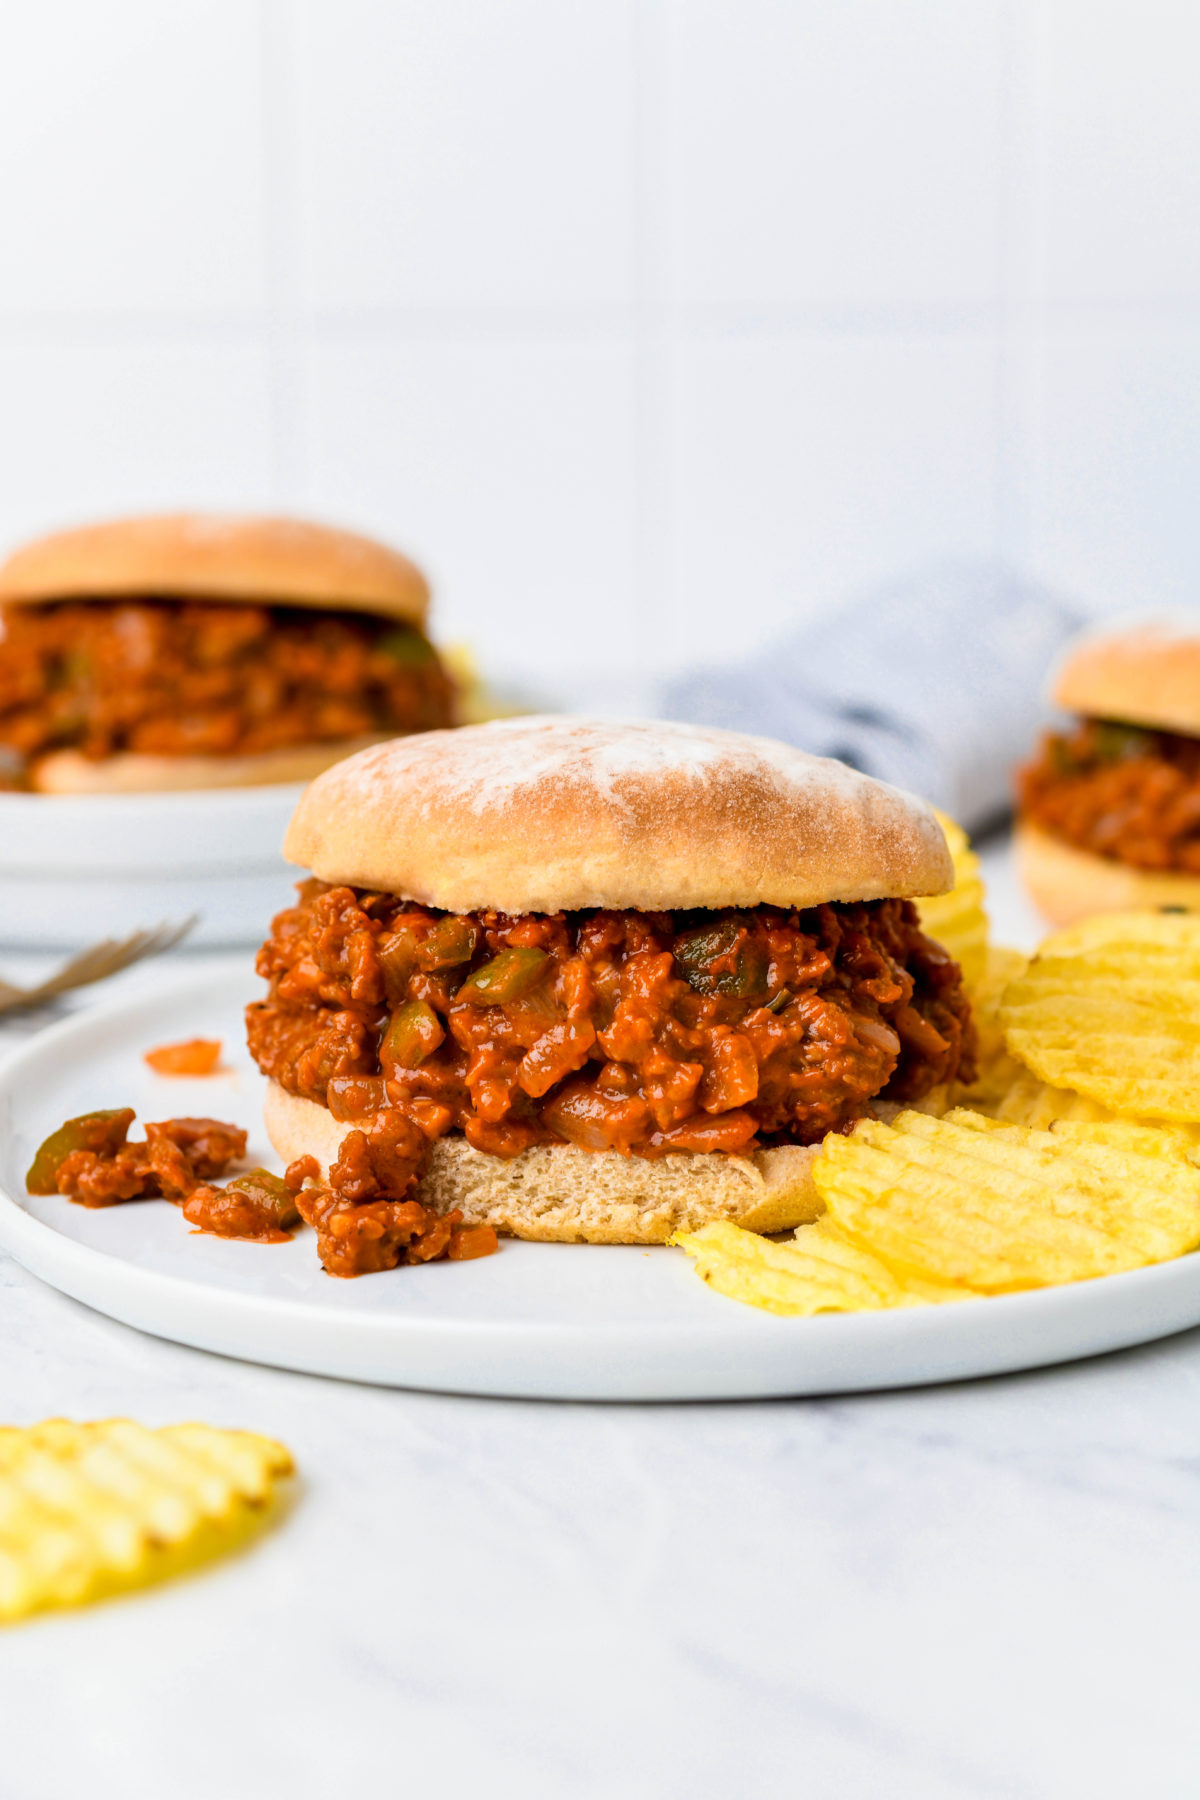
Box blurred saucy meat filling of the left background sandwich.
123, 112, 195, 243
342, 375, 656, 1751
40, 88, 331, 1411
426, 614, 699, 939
0, 599, 453, 772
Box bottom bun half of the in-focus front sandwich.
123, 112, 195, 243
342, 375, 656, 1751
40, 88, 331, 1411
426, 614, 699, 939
263, 1082, 824, 1244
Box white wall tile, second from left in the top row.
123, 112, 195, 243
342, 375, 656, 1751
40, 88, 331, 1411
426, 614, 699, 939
293, 0, 633, 313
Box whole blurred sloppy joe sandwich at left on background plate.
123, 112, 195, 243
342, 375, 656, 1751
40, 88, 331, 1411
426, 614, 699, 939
0, 513, 453, 794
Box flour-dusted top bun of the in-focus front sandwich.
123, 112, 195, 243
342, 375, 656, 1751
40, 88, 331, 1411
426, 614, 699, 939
284, 716, 954, 913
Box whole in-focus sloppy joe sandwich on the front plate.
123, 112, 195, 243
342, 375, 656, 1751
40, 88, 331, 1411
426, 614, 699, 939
248, 718, 973, 1274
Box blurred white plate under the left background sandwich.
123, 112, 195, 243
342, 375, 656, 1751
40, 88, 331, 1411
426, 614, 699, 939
0, 781, 304, 949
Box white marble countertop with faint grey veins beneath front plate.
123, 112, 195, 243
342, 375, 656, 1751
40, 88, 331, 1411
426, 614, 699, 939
0, 853, 1200, 1800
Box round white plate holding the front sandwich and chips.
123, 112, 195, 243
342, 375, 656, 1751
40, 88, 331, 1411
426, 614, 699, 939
0, 965, 1200, 1400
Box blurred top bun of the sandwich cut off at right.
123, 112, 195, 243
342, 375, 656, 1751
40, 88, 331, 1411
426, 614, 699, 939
1052, 614, 1200, 738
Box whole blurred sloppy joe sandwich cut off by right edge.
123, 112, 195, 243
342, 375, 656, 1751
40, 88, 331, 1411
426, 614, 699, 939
1016, 616, 1200, 925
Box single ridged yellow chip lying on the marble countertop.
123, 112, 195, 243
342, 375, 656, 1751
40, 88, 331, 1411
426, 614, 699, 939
0, 1418, 293, 1622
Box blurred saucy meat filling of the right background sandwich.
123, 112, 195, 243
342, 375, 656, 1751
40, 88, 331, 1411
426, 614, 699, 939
1020, 718, 1200, 875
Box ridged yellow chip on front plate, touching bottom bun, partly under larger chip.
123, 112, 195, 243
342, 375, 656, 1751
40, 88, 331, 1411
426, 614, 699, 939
671, 1219, 970, 1318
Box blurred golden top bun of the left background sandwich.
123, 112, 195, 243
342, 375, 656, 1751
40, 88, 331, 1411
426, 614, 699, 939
0, 513, 430, 625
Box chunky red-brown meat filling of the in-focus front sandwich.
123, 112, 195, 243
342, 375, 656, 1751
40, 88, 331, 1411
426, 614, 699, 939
246, 882, 973, 1195
